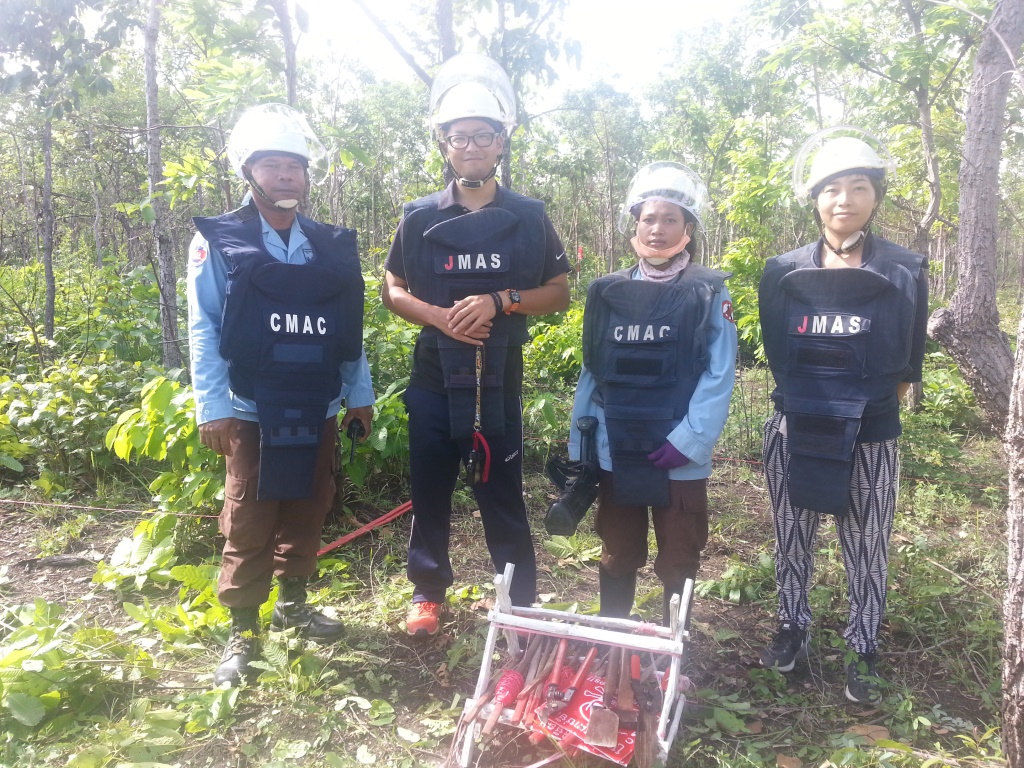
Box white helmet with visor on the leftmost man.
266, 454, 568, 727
227, 103, 327, 179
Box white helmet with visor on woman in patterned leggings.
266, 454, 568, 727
793, 125, 896, 204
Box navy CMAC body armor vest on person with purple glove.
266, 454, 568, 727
583, 264, 728, 507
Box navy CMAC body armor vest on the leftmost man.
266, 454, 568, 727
194, 204, 364, 499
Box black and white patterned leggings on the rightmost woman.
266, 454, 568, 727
764, 413, 899, 653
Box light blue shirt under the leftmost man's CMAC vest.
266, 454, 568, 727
187, 211, 376, 424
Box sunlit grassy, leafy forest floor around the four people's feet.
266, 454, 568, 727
0, 372, 1006, 768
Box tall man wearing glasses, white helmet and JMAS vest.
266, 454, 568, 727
382, 54, 569, 636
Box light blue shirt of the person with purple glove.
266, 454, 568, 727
569, 269, 737, 480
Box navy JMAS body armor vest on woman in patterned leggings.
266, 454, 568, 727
762, 238, 924, 514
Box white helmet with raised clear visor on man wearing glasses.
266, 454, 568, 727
430, 53, 515, 133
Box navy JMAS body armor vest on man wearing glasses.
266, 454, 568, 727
402, 188, 545, 439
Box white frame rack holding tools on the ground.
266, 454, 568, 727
459, 563, 693, 768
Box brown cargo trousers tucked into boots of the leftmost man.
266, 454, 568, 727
217, 418, 338, 608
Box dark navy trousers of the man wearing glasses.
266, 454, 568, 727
406, 387, 537, 605
